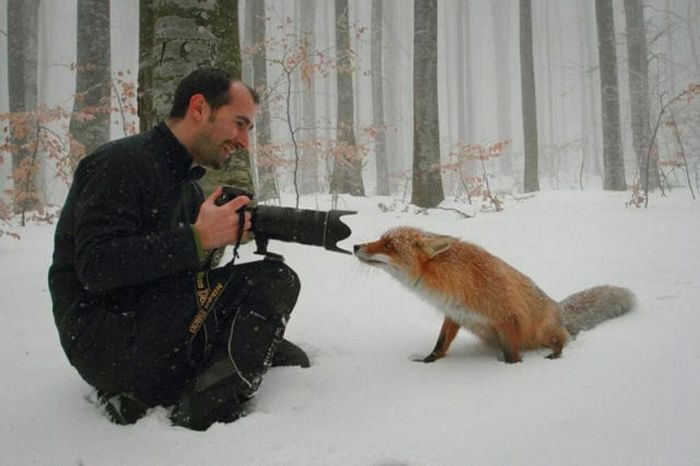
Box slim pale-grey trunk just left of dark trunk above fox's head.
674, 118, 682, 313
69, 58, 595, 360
370, 0, 391, 196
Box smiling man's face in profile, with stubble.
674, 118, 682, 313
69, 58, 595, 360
192, 82, 256, 169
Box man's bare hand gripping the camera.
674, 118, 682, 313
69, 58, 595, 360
194, 186, 251, 251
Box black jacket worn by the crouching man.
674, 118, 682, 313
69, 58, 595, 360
49, 123, 203, 391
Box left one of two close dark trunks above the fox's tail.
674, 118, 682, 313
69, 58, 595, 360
595, 0, 627, 191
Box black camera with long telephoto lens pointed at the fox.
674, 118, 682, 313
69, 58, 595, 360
215, 186, 357, 256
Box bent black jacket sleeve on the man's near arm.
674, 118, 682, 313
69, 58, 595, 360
74, 152, 199, 292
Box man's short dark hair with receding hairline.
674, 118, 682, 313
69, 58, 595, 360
168, 68, 260, 118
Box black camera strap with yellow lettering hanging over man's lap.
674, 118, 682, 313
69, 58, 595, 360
187, 209, 245, 362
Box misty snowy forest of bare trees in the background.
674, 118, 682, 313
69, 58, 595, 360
0, 0, 700, 236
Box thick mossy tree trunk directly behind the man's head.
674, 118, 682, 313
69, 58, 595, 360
139, 0, 254, 193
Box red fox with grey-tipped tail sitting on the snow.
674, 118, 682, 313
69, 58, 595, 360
353, 226, 636, 363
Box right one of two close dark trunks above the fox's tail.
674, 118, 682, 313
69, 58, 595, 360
624, 0, 658, 190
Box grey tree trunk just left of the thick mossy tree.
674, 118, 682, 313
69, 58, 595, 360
69, 0, 112, 164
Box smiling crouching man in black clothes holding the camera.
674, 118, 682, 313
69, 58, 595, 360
49, 69, 308, 430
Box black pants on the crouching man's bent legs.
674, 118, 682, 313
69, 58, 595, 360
134, 260, 300, 406
